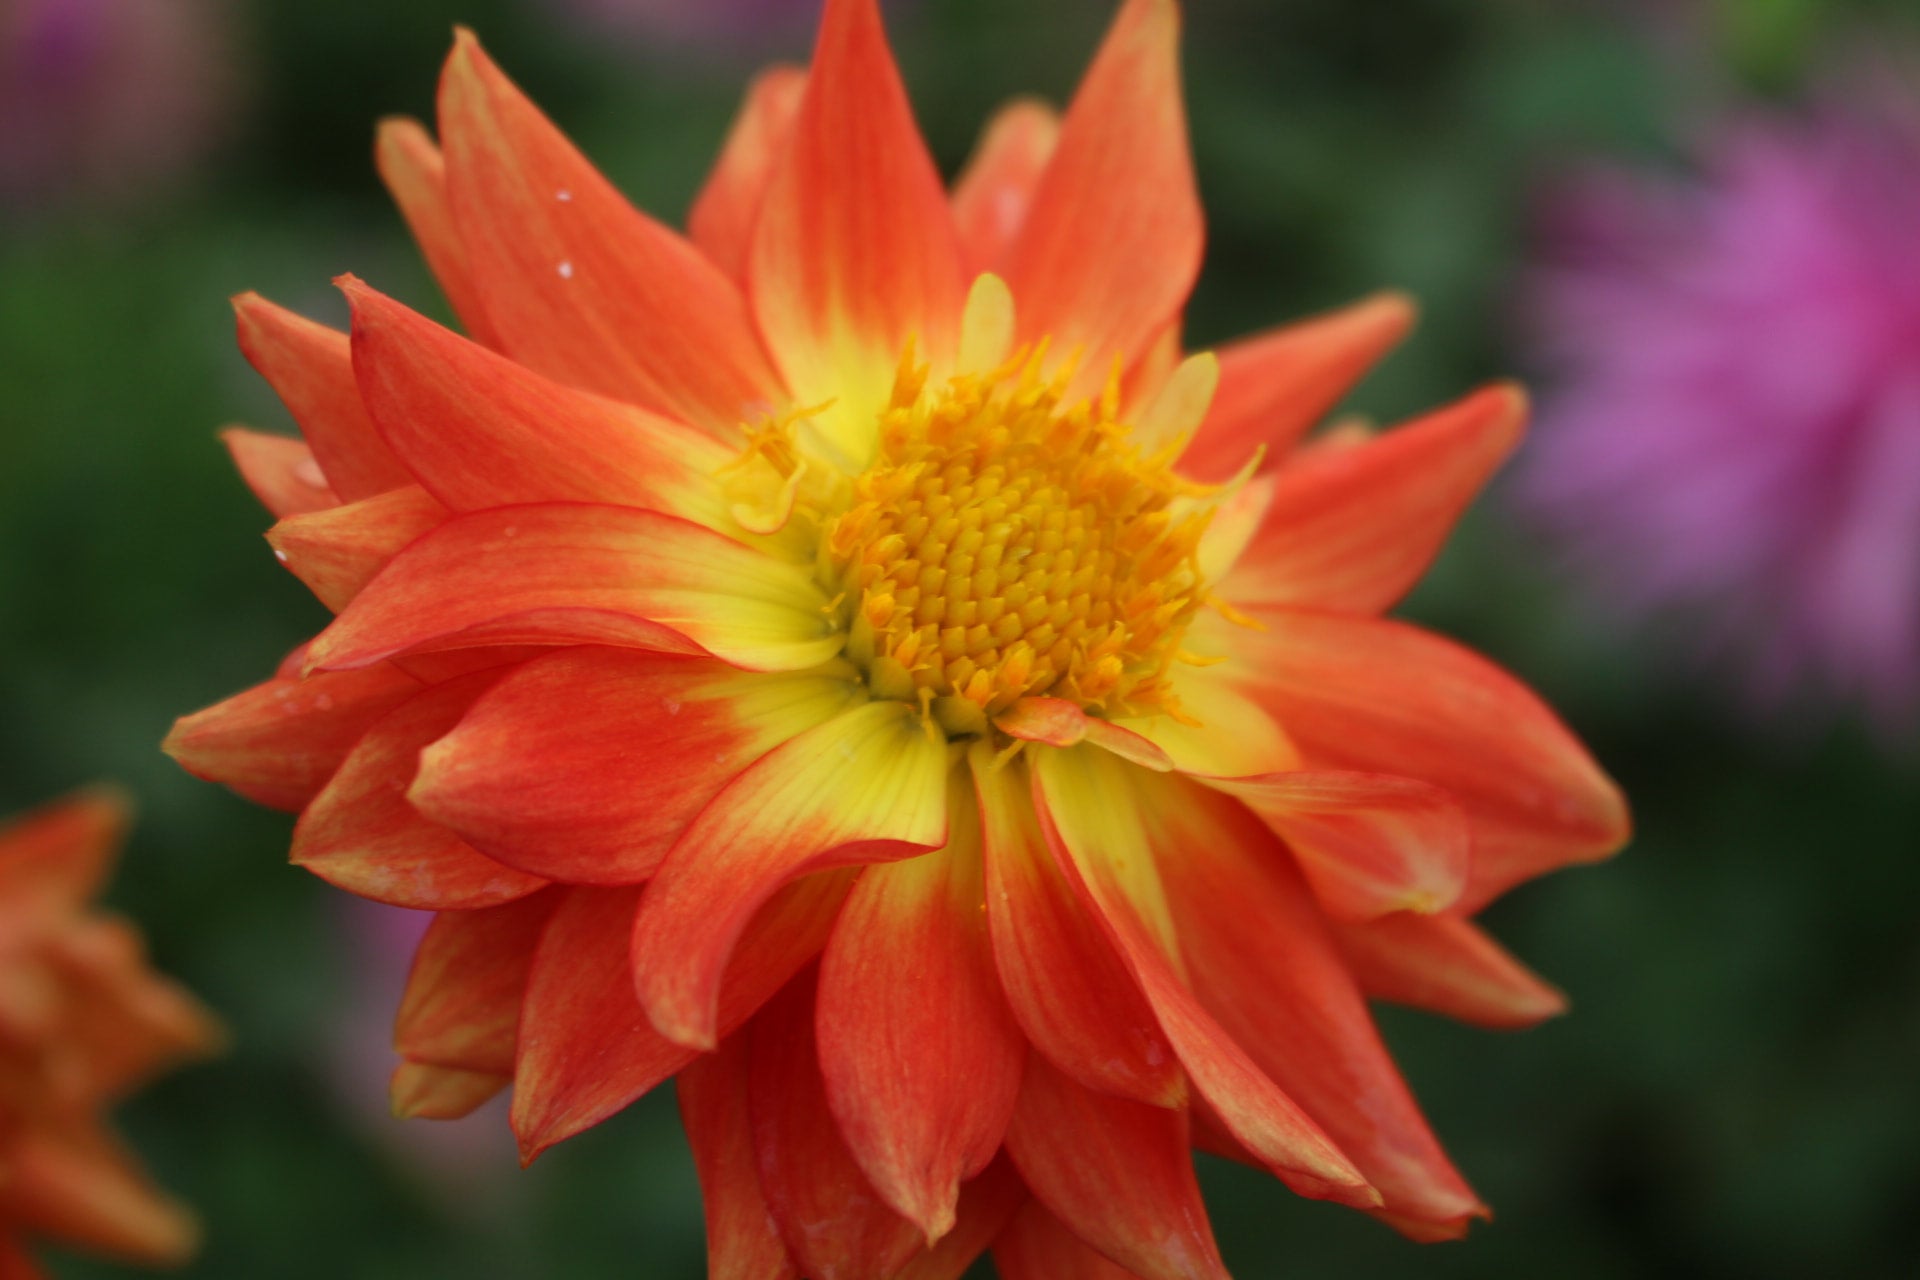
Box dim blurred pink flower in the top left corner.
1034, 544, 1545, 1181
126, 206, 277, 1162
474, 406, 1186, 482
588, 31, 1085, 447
0, 0, 236, 205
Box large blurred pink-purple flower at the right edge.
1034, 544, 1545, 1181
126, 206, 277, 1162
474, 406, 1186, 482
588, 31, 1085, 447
1521, 77, 1920, 731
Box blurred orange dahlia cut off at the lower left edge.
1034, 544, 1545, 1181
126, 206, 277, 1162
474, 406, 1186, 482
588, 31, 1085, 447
0, 789, 223, 1280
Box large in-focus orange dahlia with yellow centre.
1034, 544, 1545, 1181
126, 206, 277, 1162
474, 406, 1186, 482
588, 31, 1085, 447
169, 0, 1626, 1280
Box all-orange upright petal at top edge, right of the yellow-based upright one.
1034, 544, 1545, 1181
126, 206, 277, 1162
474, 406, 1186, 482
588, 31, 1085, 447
1006, 0, 1204, 386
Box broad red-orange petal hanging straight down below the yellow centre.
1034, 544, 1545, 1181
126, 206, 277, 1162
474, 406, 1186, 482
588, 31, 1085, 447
816, 802, 1027, 1244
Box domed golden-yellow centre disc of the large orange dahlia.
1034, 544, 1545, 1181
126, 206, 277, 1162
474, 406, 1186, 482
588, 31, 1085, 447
824, 339, 1212, 725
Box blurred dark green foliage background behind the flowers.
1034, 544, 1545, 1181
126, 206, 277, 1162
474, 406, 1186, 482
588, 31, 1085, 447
0, 0, 1920, 1280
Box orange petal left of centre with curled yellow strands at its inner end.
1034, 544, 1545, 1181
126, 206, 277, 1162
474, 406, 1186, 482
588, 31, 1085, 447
340, 276, 737, 524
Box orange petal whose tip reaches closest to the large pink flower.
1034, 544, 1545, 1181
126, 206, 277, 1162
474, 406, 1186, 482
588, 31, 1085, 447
1219, 386, 1526, 614
